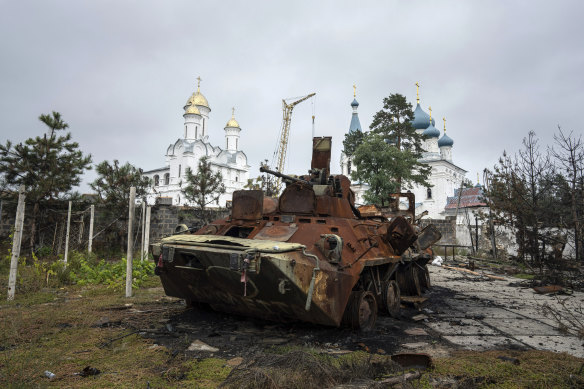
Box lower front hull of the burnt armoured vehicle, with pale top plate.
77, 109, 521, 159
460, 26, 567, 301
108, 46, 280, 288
153, 235, 354, 326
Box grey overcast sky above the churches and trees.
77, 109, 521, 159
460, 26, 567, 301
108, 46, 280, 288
0, 0, 584, 192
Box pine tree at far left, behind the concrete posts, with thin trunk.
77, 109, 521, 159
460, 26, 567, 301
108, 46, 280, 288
0, 111, 91, 250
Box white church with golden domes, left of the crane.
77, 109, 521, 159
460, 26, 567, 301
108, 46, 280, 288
144, 77, 250, 208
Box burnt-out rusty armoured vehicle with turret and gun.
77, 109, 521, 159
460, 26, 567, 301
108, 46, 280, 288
152, 137, 440, 330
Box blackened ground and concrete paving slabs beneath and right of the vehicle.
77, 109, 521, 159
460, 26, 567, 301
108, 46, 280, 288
126, 260, 584, 358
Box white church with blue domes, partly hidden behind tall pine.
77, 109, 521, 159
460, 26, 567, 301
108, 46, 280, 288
341, 85, 466, 219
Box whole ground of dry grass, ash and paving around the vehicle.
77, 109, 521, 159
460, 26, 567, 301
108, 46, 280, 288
0, 256, 584, 388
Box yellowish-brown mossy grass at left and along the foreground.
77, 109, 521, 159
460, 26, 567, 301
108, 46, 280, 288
0, 256, 584, 388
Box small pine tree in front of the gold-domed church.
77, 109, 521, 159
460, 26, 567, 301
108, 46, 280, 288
182, 157, 225, 223
